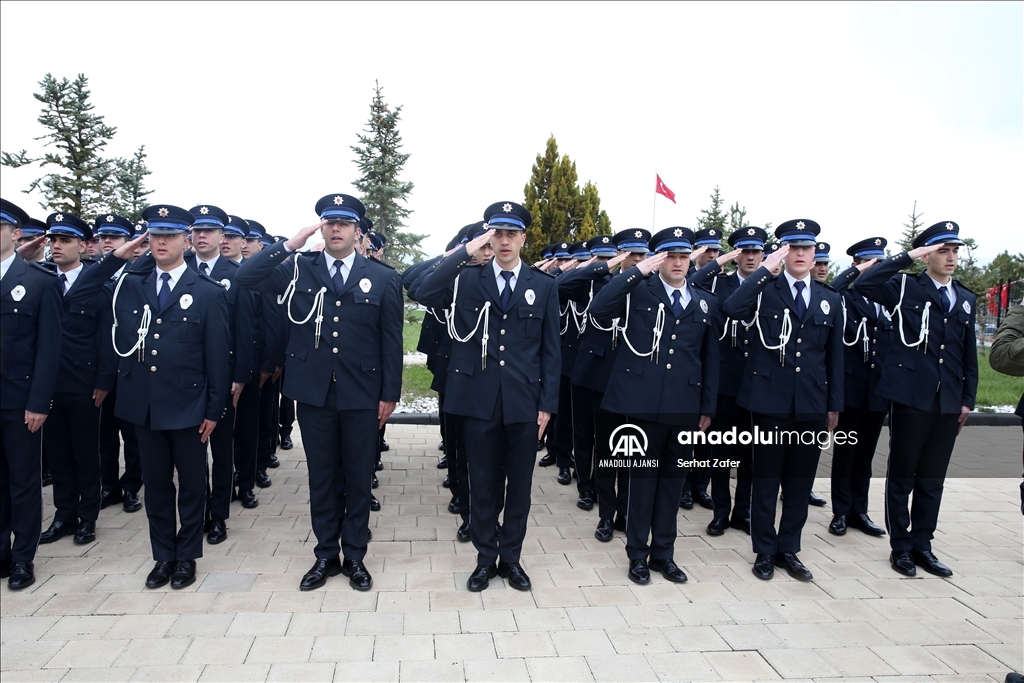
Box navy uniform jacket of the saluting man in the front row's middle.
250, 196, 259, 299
417, 247, 561, 424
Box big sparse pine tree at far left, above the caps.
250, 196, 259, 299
0, 74, 117, 217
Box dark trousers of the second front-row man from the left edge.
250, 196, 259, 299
135, 423, 207, 562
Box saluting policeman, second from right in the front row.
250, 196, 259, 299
725, 219, 843, 581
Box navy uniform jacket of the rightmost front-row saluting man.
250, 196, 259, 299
853, 252, 978, 414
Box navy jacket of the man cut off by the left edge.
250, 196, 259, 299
0, 254, 61, 415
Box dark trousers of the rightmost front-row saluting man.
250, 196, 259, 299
886, 394, 959, 551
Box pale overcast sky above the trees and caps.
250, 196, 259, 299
0, 2, 1024, 260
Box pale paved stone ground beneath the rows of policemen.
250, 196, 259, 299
0, 426, 1024, 681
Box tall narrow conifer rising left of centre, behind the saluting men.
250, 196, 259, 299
351, 81, 426, 266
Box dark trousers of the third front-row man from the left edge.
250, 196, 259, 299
296, 382, 377, 561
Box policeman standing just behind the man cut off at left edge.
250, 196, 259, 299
39, 212, 113, 545
